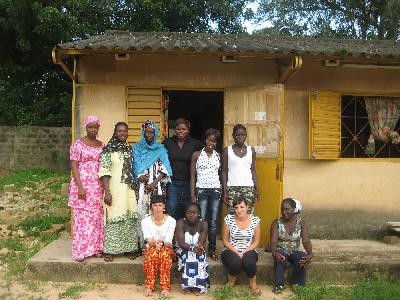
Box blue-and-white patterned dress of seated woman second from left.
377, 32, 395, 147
176, 221, 210, 293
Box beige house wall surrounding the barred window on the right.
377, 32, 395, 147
283, 60, 400, 238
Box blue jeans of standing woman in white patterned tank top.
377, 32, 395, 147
197, 188, 221, 253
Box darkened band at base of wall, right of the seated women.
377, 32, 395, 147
301, 210, 399, 240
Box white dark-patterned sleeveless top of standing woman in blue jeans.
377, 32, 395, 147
196, 149, 221, 189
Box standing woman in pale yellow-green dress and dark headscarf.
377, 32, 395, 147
99, 122, 138, 261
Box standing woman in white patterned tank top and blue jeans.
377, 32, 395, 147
190, 128, 221, 260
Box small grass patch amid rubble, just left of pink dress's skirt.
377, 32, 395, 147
19, 214, 69, 235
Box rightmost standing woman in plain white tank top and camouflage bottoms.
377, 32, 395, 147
222, 124, 259, 214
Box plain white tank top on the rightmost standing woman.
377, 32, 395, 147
227, 145, 254, 186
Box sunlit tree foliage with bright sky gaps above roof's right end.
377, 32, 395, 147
257, 0, 400, 39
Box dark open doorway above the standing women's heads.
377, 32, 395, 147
164, 90, 224, 152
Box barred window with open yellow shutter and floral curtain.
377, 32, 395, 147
309, 91, 400, 159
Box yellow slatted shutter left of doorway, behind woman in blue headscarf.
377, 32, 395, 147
126, 87, 164, 144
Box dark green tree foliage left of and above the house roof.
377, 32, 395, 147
0, 0, 250, 126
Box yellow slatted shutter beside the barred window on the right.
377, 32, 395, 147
309, 90, 341, 159
